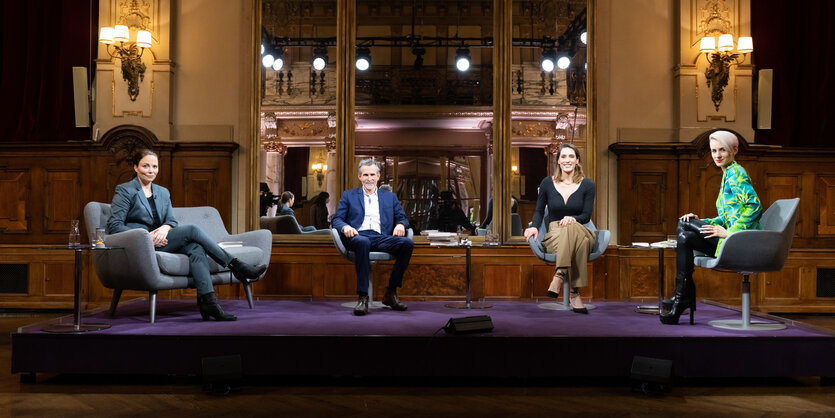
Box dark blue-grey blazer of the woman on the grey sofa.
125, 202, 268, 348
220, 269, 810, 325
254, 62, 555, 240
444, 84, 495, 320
107, 178, 177, 234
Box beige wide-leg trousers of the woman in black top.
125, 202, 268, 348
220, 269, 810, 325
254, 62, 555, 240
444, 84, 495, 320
542, 221, 594, 288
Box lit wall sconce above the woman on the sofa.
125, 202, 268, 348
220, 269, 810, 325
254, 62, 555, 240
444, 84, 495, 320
99, 25, 151, 101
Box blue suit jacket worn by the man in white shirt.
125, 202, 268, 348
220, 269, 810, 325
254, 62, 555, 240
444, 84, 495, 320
331, 188, 409, 235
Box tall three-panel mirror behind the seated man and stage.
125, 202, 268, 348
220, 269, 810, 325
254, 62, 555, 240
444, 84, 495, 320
259, 0, 587, 242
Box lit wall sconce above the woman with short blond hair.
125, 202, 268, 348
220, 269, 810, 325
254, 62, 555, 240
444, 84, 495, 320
699, 33, 754, 111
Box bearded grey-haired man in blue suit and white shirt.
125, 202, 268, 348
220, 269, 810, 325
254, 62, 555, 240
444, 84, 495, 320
331, 158, 414, 315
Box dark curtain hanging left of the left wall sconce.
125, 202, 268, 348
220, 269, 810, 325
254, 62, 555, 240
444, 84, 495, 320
0, 0, 99, 142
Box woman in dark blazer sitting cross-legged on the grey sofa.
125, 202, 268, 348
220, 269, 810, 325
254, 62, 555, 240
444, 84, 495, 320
107, 150, 267, 321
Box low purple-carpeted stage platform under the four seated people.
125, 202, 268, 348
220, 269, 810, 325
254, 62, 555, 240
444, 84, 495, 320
12, 300, 835, 377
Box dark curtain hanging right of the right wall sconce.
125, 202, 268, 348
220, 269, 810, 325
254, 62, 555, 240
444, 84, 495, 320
751, 0, 835, 148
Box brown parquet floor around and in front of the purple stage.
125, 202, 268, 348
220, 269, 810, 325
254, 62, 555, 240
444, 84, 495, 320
0, 313, 835, 418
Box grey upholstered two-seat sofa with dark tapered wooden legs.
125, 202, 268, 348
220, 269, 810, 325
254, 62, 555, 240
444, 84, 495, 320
84, 202, 272, 323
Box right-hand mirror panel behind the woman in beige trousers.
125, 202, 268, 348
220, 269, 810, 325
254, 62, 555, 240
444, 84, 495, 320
506, 0, 588, 242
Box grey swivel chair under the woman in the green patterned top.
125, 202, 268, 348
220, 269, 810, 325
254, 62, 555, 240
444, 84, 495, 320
694, 198, 800, 331
